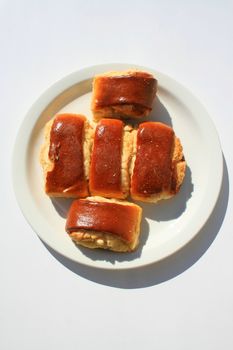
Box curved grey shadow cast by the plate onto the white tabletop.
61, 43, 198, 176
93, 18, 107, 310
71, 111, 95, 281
45, 159, 229, 289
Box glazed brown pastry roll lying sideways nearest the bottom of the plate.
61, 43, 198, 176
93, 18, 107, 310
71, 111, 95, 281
66, 197, 142, 252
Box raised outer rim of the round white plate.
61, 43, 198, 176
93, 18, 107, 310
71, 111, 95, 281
11, 63, 223, 270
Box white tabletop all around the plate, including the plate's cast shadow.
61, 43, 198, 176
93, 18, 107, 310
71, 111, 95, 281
0, 0, 233, 350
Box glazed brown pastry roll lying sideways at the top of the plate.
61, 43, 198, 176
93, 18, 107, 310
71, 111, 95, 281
91, 70, 157, 120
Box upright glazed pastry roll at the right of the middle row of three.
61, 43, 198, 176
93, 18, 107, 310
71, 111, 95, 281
131, 122, 186, 202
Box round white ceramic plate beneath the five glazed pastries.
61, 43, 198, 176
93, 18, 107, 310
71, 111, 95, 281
13, 64, 223, 269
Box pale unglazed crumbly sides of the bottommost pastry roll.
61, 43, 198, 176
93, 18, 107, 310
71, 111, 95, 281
65, 196, 142, 252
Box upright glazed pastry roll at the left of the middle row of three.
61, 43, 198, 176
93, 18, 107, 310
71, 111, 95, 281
40, 114, 92, 197
